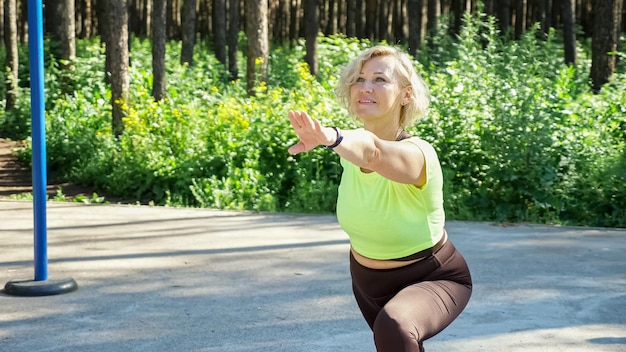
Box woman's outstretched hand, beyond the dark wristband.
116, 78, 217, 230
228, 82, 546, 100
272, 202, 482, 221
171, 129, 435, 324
288, 111, 335, 154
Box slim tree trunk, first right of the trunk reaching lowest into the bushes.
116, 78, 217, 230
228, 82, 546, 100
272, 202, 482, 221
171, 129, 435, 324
152, 0, 167, 101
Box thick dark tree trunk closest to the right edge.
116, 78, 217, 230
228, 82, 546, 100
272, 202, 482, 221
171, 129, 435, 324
590, 0, 623, 92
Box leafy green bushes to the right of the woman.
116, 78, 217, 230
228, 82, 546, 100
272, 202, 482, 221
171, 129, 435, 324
418, 13, 626, 226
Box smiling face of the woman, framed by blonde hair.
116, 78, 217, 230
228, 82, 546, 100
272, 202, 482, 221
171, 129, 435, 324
350, 56, 402, 123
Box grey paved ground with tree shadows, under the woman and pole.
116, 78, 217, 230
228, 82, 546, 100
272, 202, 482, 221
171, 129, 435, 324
0, 201, 626, 352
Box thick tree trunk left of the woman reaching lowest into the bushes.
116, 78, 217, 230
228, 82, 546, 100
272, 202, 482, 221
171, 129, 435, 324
106, 0, 130, 137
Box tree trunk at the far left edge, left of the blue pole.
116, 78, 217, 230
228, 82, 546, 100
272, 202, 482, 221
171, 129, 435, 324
4, 0, 19, 111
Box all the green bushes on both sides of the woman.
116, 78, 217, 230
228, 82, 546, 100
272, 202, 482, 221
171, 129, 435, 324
0, 15, 626, 227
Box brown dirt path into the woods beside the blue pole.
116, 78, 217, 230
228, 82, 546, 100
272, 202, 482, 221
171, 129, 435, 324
0, 138, 108, 201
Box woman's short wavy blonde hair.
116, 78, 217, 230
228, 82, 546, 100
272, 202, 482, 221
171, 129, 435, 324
335, 45, 430, 127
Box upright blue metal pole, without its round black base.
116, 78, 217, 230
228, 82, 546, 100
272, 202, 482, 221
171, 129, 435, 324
28, 0, 48, 281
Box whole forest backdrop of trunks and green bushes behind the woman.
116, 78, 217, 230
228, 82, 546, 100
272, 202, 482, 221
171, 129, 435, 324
0, 0, 626, 227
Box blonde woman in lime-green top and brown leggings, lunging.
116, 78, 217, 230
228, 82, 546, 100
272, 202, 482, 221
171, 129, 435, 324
289, 46, 472, 352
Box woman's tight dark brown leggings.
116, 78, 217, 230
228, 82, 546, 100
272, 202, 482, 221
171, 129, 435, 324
350, 239, 472, 352
